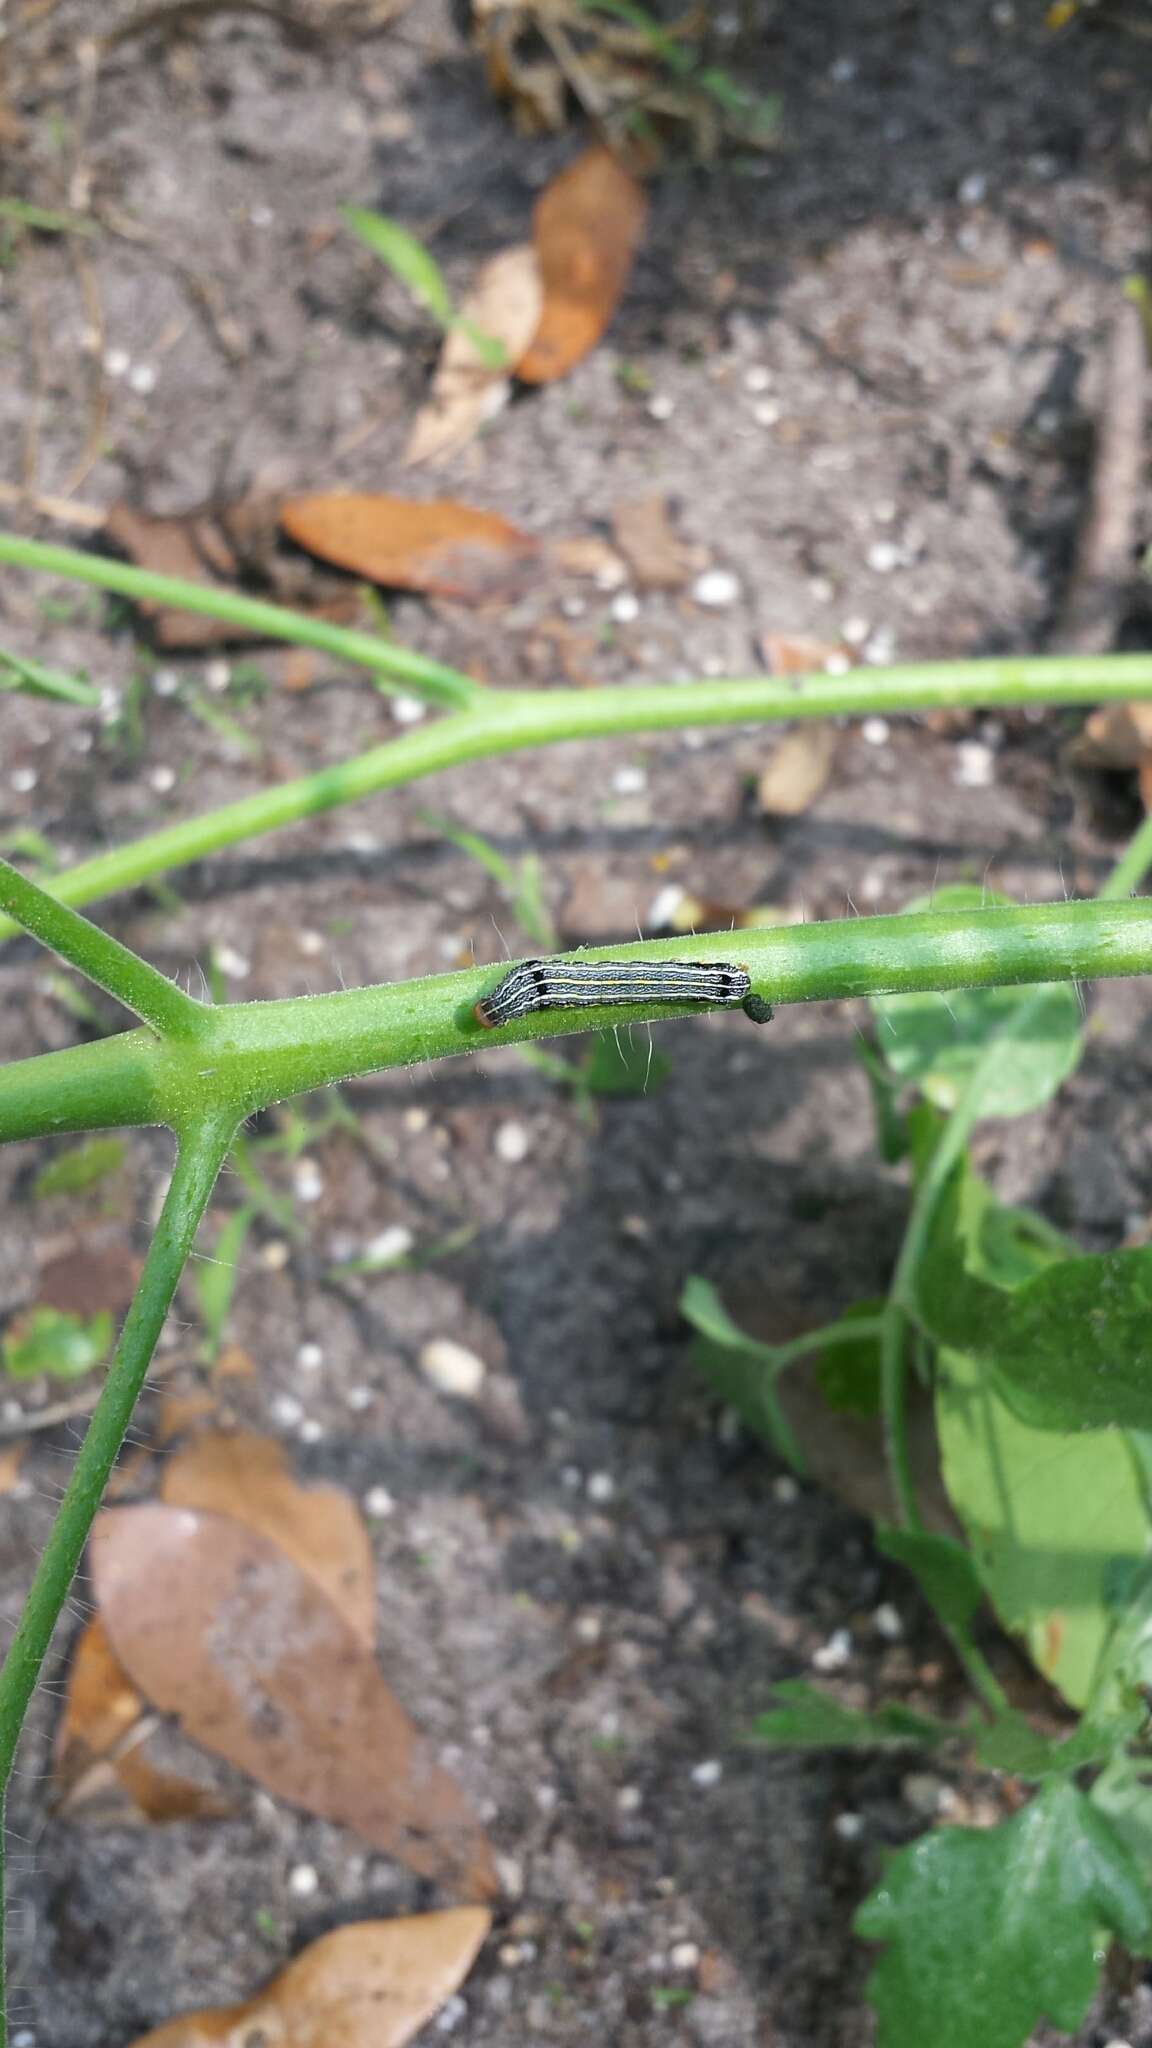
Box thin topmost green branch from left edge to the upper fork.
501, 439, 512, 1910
0, 532, 484, 705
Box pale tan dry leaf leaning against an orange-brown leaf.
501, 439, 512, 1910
404, 242, 543, 465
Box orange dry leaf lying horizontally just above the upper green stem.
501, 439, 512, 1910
281, 492, 535, 604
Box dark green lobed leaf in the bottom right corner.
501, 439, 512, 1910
855, 1780, 1148, 2048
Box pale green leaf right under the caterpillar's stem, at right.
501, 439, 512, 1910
871, 885, 1082, 1116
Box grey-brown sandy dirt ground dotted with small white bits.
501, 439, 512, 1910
0, 0, 1152, 2048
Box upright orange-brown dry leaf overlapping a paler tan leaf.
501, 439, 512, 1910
517, 147, 648, 383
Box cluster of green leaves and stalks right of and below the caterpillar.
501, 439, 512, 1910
683, 889, 1152, 2048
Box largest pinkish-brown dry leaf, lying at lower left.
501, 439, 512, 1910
92, 1505, 496, 1898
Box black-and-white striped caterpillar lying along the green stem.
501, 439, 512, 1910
474, 961, 773, 1030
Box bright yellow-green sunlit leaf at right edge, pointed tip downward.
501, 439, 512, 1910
937, 1343, 1148, 1706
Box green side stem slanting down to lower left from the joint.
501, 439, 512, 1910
0, 1114, 236, 2048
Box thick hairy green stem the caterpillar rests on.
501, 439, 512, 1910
0, 897, 1152, 1143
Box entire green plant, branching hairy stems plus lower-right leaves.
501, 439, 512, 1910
0, 535, 1152, 2048
